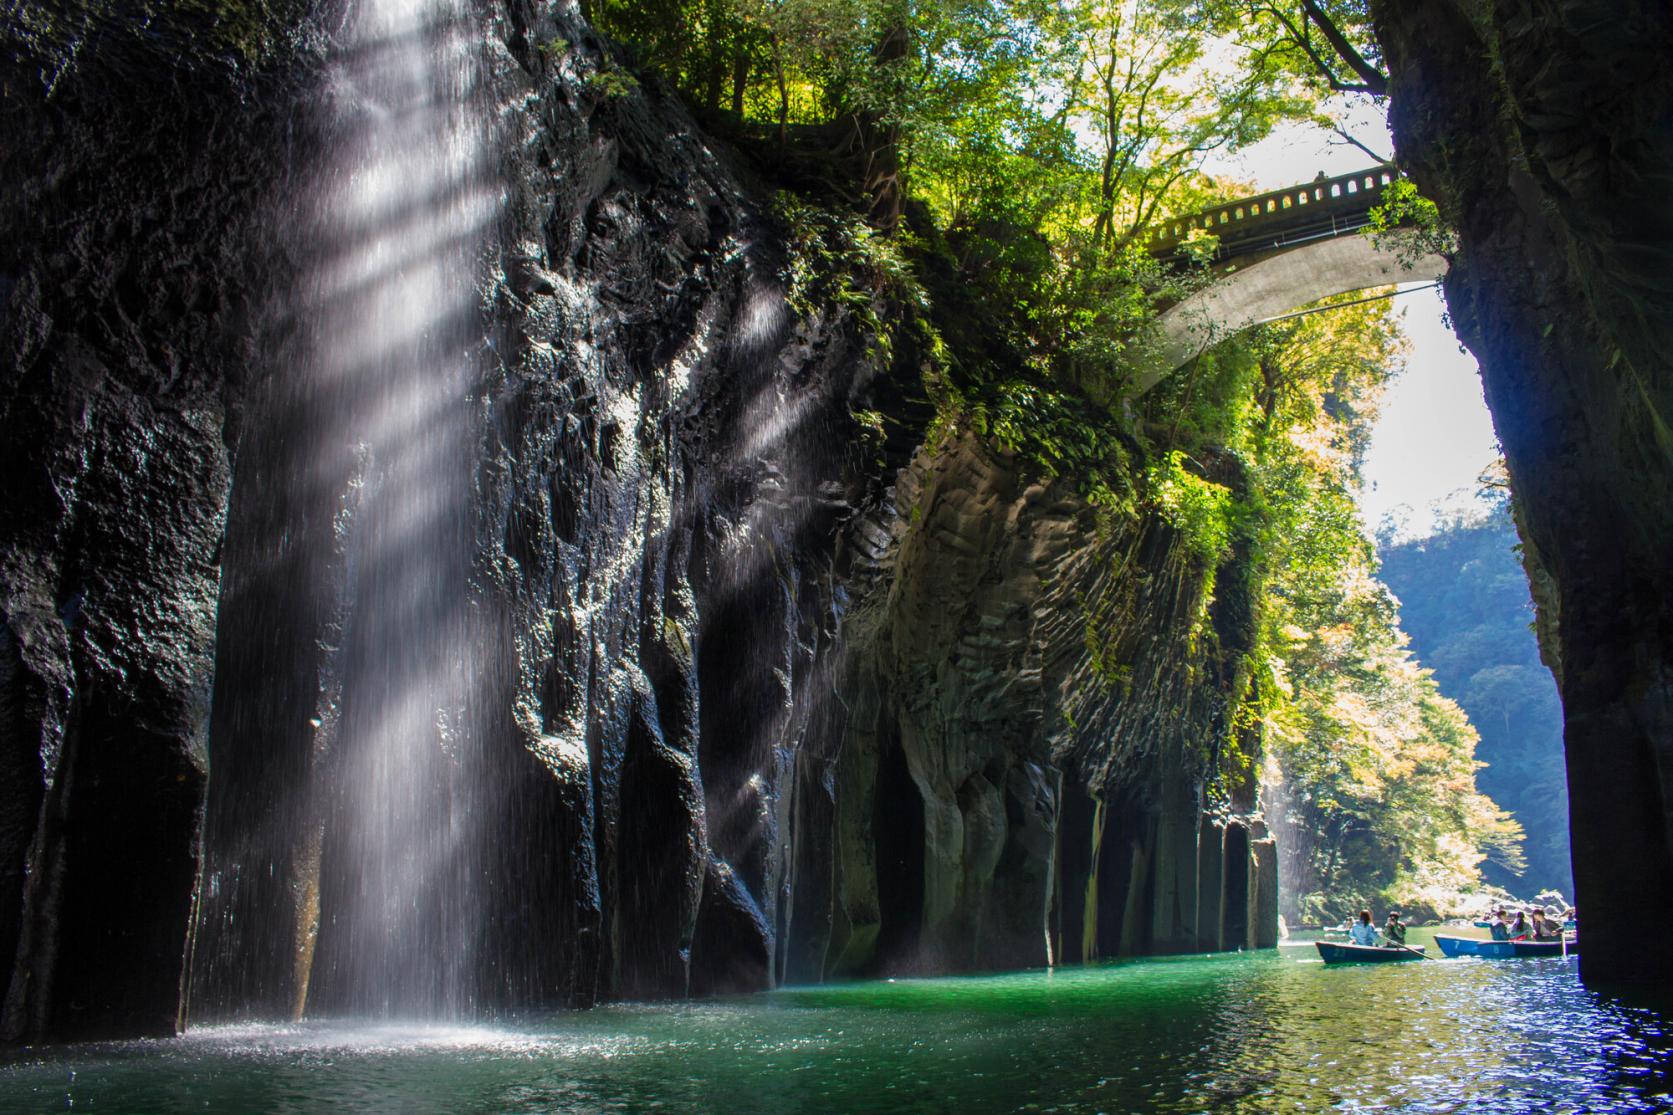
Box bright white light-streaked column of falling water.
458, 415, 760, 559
264, 0, 499, 1016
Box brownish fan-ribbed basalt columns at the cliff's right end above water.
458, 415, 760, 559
796, 439, 1276, 973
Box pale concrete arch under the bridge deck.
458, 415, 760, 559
1138, 234, 1447, 393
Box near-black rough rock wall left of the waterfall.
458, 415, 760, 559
0, 30, 307, 1040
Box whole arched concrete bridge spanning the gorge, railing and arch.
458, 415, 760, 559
1136, 166, 1447, 393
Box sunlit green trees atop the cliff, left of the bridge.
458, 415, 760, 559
592, 0, 1317, 348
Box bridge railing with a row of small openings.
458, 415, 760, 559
1149, 164, 1399, 258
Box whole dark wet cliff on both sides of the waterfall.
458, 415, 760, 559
0, 3, 1275, 1038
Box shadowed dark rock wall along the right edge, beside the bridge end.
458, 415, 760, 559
1374, 0, 1673, 983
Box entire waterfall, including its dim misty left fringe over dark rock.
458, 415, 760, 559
194, 0, 500, 1016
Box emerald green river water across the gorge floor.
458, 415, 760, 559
0, 934, 1673, 1113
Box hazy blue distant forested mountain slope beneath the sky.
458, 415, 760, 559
1380, 506, 1574, 897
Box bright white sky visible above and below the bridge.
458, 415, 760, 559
1205, 97, 1499, 537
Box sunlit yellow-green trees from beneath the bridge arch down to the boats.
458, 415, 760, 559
1186, 303, 1522, 921
